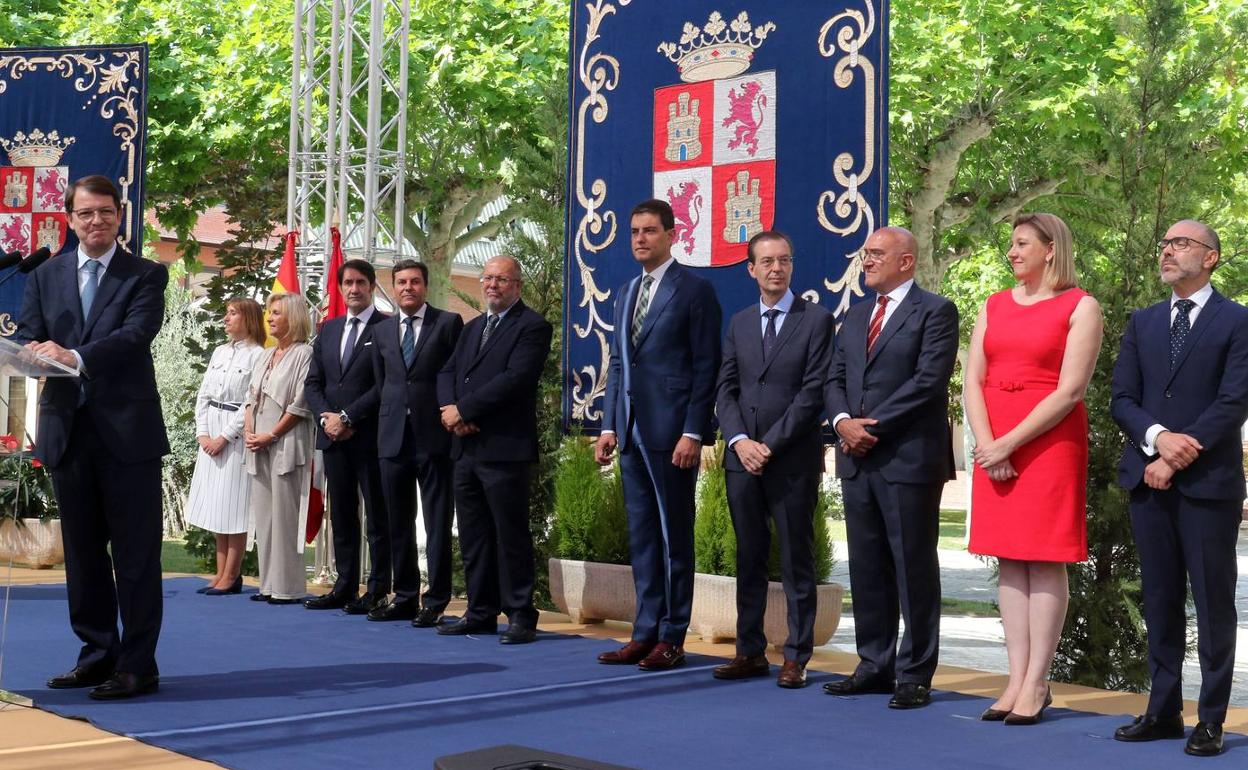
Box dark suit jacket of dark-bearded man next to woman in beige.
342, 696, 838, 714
303, 309, 387, 449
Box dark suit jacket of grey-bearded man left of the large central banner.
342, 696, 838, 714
438, 300, 554, 462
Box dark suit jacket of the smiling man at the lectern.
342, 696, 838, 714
14, 247, 168, 467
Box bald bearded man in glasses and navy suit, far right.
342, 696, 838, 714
1112, 220, 1248, 756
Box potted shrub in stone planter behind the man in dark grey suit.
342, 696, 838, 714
689, 441, 845, 649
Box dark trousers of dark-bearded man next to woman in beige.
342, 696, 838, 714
323, 436, 391, 597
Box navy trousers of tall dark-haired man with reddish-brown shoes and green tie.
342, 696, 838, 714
620, 431, 698, 646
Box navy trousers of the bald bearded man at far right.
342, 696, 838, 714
1131, 484, 1242, 723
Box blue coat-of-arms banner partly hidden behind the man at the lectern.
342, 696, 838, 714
0, 45, 147, 337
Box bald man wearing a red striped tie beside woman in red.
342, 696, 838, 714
824, 227, 957, 709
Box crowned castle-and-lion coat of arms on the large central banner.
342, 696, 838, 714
653, 11, 776, 267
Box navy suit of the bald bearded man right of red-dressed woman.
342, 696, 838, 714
1112, 292, 1248, 723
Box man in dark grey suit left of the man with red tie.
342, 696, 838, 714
714, 231, 834, 688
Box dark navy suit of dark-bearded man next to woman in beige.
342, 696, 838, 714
303, 311, 391, 597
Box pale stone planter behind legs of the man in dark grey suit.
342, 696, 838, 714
689, 573, 845, 649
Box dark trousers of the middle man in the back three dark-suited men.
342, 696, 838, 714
381, 428, 454, 612
